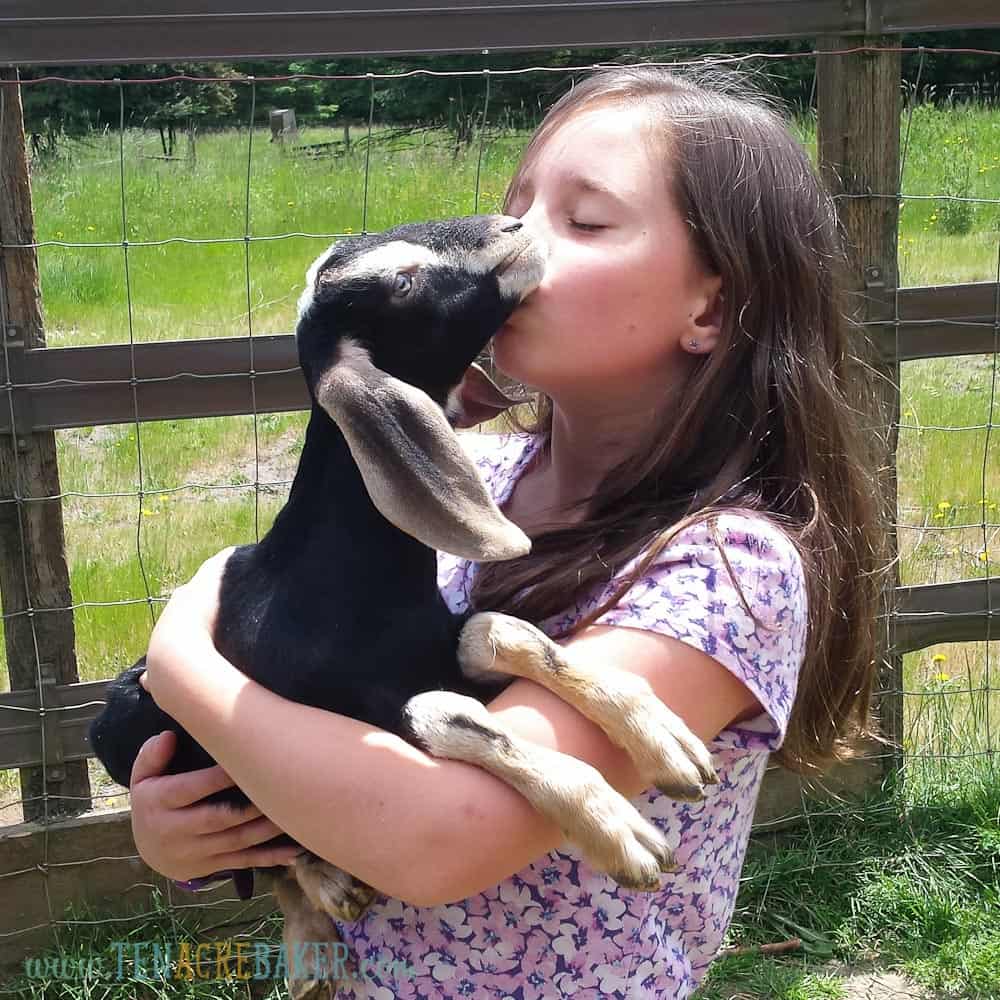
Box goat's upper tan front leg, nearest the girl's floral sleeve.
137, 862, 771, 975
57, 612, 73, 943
458, 612, 719, 802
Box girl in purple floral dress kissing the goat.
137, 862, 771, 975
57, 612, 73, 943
132, 67, 882, 1000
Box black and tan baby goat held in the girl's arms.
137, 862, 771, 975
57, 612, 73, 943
90, 216, 716, 998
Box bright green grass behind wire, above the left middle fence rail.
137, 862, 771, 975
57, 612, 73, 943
32, 129, 524, 347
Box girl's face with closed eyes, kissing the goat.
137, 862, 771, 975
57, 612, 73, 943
493, 107, 721, 401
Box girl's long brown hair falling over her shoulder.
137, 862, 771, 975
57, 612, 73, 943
470, 66, 886, 773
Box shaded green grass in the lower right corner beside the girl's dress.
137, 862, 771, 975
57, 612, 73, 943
698, 757, 1000, 1000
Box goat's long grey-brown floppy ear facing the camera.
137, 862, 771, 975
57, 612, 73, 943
316, 345, 531, 562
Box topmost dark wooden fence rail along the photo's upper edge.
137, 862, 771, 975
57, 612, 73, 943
0, 0, 1000, 66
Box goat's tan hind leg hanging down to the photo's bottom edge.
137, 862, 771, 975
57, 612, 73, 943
272, 871, 356, 1000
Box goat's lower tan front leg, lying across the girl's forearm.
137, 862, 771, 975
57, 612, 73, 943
404, 691, 676, 890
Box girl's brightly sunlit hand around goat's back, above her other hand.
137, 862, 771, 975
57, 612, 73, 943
139, 547, 234, 708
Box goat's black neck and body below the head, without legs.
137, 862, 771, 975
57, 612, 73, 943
91, 406, 498, 804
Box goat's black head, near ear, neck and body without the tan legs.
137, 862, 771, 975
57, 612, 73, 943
90, 216, 544, 898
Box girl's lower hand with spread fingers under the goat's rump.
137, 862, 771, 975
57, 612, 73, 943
129, 730, 302, 881
